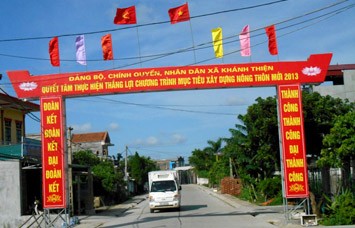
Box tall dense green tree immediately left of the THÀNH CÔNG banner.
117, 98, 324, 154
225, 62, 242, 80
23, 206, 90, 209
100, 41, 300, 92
238, 97, 280, 179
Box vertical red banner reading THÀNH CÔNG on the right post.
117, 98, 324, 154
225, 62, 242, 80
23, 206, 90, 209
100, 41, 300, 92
277, 84, 309, 198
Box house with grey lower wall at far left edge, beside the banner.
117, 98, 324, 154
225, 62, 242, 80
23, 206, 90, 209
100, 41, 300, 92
0, 93, 42, 227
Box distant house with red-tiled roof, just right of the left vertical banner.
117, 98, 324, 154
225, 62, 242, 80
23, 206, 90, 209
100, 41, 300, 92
71, 131, 114, 158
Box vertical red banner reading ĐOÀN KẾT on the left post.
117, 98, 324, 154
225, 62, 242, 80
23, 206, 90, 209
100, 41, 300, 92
40, 97, 66, 208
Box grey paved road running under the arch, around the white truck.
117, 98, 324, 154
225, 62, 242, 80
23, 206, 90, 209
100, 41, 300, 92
75, 185, 301, 228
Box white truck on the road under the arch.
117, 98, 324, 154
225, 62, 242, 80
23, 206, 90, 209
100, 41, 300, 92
148, 170, 181, 213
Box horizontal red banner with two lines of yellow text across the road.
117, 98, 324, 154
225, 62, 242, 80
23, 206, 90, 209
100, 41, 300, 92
7, 53, 332, 99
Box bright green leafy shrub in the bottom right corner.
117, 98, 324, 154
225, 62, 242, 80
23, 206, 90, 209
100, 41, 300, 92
322, 190, 355, 226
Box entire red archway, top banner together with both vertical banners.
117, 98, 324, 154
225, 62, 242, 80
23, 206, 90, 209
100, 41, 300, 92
7, 53, 332, 208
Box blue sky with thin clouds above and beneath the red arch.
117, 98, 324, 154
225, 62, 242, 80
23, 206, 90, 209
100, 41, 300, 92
0, 0, 355, 161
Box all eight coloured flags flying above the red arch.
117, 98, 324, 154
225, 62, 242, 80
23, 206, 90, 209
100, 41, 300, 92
49, 3, 278, 67
